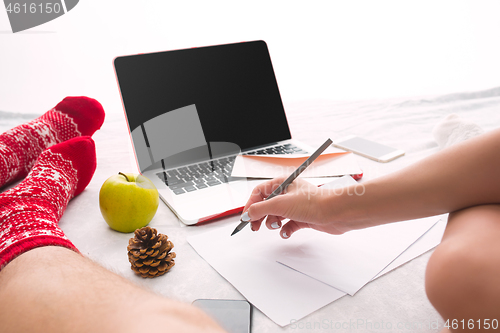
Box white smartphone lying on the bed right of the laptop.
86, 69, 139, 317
333, 135, 405, 162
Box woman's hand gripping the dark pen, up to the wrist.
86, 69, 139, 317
243, 177, 349, 238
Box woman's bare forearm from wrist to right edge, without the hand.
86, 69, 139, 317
329, 126, 500, 225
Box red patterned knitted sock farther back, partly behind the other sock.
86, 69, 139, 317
0, 97, 104, 187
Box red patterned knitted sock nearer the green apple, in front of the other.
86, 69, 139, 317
0, 136, 96, 269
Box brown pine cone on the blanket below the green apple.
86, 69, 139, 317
127, 227, 175, 278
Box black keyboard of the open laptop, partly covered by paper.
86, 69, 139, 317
156, 143, 307, 195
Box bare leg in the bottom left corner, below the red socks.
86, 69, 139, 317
0, 246, 223, 333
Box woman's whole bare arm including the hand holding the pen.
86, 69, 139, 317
245, 130, 500, 238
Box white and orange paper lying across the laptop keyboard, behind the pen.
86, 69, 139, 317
231, 152, 362, 178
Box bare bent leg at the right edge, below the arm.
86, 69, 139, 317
426, 205, 500, 332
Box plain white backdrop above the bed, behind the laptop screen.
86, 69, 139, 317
0, 0, 500, 113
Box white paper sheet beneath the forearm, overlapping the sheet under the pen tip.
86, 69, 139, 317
275, 217, 438, 295
